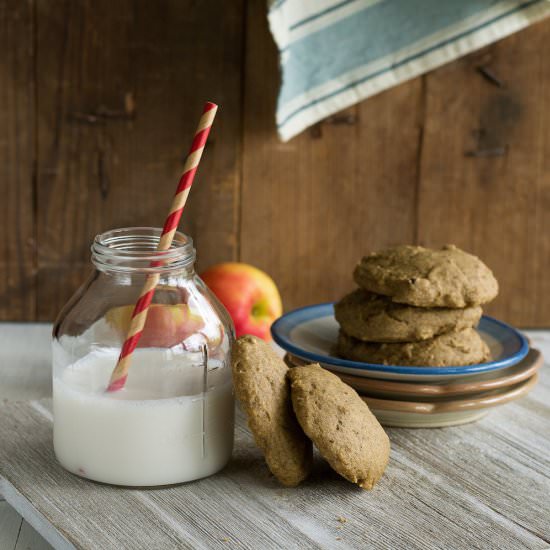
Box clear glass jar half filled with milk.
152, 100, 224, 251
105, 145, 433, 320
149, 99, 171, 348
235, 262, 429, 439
52, 227, 234, 486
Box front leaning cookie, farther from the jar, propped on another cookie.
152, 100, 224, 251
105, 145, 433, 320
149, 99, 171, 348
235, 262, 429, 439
288, 365, 390, 489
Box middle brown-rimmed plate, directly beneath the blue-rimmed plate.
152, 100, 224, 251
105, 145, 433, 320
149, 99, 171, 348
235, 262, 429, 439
285, 349, 543, 399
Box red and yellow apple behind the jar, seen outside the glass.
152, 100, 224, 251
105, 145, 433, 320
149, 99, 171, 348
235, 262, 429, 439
201, 262, 283, 341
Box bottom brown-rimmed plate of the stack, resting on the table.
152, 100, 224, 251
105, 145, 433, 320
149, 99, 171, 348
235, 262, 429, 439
363, 373, 538, 428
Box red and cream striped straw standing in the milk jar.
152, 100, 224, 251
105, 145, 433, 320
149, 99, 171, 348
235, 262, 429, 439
107, 102, 218, 392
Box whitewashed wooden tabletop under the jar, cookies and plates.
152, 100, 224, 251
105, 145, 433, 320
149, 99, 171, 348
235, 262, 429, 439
0, 324, 550, 550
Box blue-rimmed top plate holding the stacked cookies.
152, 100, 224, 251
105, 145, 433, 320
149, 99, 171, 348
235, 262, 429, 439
271, 303, 529, 381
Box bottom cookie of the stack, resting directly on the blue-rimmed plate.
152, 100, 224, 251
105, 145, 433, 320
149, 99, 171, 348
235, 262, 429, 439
336, 328, 490, 367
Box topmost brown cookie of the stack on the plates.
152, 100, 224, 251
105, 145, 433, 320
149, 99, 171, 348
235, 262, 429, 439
354, 245, 498, 308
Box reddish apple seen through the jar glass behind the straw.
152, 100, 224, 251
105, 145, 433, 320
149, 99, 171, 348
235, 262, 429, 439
105, 304, 204, 348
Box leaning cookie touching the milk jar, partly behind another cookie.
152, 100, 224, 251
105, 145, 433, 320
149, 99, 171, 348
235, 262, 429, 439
231, 336, 313, 487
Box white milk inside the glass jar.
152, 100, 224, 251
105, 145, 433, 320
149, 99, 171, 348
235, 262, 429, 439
53, 349, 234, 486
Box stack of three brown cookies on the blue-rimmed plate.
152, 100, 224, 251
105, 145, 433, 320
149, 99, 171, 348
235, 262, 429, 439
335, 245, 498, 367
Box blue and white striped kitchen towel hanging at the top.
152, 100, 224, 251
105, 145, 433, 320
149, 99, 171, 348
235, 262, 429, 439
268, 0, 550, 141
